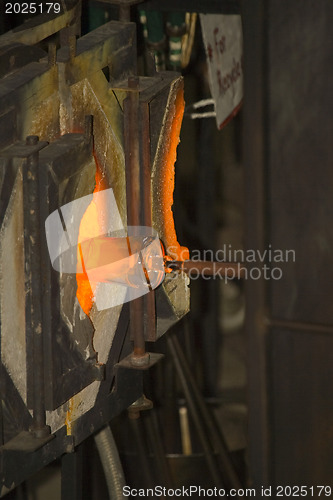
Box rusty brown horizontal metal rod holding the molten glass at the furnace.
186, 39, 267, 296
165, 260, 245, 279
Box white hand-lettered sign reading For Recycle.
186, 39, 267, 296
200, 14, 243, 129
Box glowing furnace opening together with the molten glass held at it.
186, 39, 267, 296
76, 156, 164, 314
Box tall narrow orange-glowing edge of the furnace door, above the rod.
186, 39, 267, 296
161, 88, 190, 260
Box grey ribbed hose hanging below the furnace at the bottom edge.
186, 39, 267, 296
95, 425, 126, 500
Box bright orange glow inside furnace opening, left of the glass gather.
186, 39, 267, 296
76, 154, 107, 316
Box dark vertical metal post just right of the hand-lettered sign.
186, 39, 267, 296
242, 0, 271, 487
